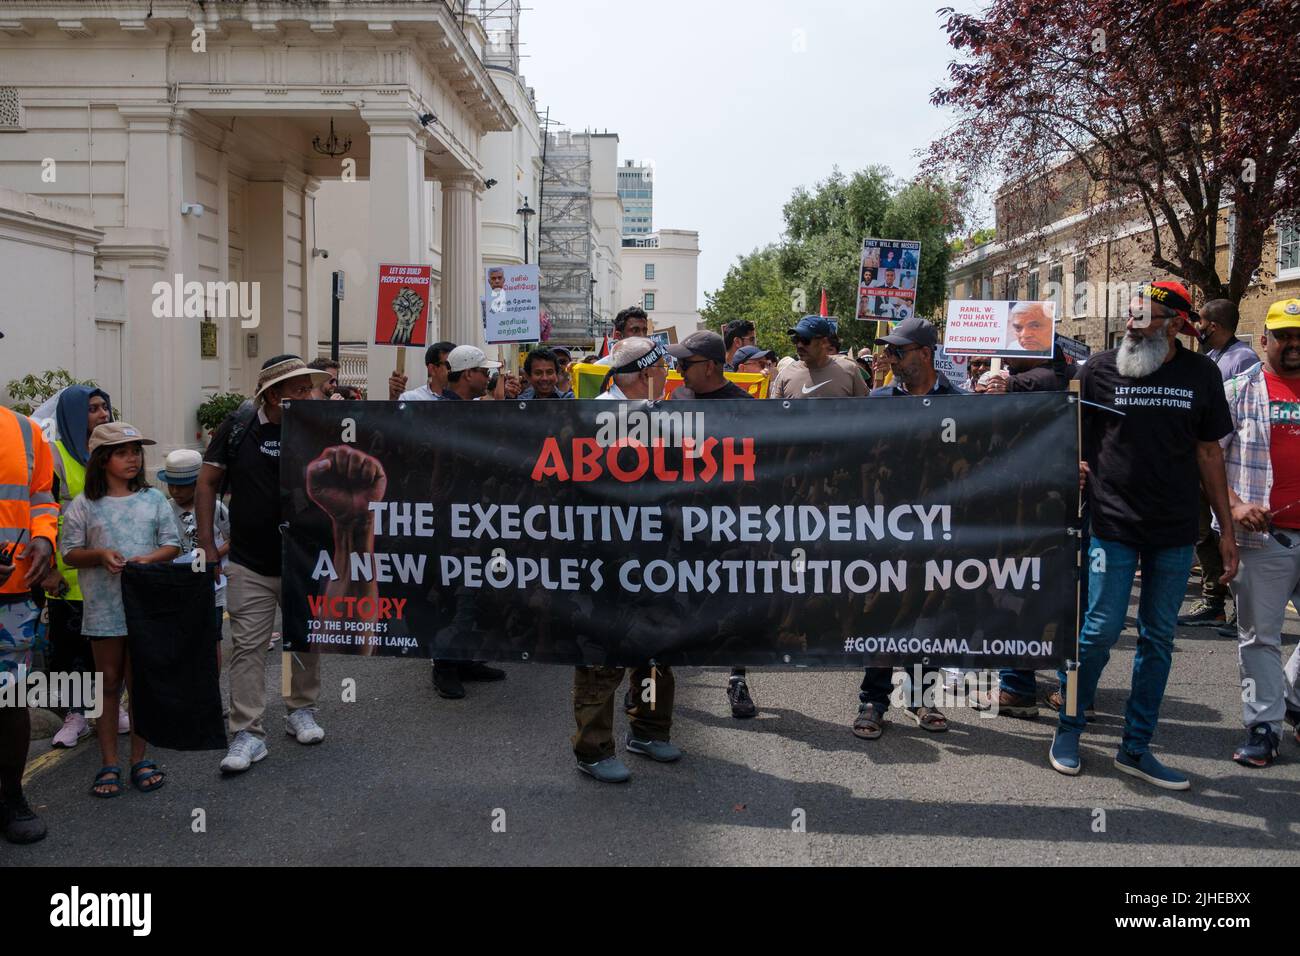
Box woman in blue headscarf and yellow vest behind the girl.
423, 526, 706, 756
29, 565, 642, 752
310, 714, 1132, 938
42, 385, 115, 747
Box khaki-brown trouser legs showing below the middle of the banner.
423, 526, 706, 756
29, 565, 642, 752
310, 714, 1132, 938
573, 666, 676, 763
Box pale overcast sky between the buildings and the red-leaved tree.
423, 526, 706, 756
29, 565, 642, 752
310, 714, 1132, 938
520, 0, 975, 304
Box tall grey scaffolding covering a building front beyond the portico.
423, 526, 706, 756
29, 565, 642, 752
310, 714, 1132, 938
537, 130, 594, 345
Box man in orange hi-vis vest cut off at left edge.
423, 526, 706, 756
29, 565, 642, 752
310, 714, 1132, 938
0, 333, 59, 843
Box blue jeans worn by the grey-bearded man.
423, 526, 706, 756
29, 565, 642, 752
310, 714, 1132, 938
1057, 537, 1195, 756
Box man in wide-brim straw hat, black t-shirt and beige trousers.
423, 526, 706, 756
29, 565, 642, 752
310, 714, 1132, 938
196, 355, 329, 774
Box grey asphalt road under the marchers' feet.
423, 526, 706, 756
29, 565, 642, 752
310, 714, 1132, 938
0, 582, 1300, 866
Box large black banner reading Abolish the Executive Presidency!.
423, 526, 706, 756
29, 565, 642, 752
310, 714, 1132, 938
281, 394, 1079, 669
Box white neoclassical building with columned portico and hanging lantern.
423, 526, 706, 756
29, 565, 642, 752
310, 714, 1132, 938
0, 0, 517, 454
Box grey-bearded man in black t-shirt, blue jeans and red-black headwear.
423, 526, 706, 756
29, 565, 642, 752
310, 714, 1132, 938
1049, 282, 1236, 790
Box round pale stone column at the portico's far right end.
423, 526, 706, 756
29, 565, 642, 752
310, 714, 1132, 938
439, 173, 486, 351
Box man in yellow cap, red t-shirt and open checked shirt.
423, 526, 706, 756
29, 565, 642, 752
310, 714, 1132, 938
1222, 299, 1300, 767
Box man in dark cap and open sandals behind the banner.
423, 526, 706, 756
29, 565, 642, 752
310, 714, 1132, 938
853, 317, 962, 740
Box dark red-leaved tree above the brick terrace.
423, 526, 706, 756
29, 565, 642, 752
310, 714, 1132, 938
930, 0, 1300, 302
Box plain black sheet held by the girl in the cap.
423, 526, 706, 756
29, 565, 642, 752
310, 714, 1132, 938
122, 563, 226, 750
